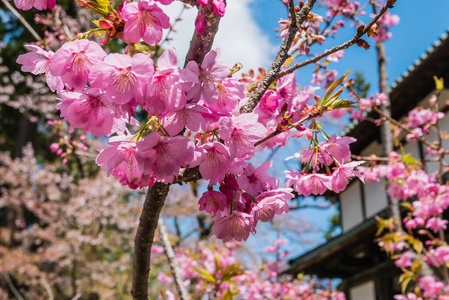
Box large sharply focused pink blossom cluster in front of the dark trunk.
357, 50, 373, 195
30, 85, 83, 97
18, 40, 298, 240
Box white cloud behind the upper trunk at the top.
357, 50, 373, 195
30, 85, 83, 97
163, 0, 276, 71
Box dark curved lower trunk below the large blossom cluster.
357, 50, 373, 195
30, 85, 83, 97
131, 182, 170, 300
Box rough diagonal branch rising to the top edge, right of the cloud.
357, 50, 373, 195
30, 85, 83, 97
240, 0, 316, 113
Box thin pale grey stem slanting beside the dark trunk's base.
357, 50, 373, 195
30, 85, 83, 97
157, 218, 189, 300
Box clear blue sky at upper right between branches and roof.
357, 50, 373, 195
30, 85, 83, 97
250, 0, 449, 92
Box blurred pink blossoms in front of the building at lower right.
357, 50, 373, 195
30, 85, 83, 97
358, 152, 449, 300
